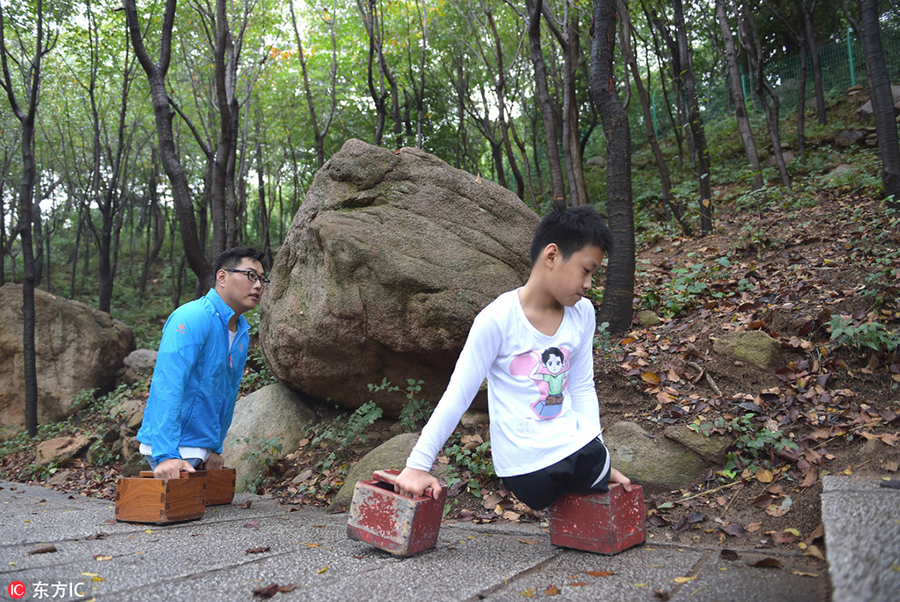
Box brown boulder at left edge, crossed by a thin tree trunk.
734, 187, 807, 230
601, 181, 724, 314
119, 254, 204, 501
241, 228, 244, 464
0, 284, 134, 425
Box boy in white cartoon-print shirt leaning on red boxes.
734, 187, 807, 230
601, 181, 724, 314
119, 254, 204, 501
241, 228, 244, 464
395, 205, 631, 510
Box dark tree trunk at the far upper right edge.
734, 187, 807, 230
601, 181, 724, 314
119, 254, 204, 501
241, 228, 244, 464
859, 0, 900, 208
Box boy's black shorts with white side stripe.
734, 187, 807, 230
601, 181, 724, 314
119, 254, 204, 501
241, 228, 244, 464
503, 437, 609, 510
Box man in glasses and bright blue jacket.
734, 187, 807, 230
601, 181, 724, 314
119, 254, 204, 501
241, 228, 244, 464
137, 247, 269, 479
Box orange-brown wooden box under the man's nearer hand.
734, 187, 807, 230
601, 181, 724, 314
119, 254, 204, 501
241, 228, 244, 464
116, 470, 206, 524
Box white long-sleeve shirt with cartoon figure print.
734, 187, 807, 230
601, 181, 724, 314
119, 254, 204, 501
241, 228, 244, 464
406, 289, 600, 477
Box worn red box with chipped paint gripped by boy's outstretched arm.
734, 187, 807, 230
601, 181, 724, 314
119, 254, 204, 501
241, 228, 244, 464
347, 470, 447, 556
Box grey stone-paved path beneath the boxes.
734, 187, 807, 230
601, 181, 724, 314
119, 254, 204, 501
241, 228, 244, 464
0, 481, 836, 602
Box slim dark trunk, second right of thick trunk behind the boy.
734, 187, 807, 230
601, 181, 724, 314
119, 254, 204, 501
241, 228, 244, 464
672, 0, 712, 234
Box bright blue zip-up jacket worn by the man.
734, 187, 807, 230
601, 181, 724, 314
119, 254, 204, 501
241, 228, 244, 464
137, 289, 250, 463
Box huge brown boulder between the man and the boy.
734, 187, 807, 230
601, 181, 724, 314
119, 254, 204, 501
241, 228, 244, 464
259, 140, 538, 416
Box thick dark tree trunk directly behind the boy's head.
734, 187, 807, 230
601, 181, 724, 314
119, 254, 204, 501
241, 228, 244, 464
589, 0, 635, 333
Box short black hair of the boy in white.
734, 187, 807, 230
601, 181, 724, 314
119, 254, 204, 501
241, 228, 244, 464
531, 205, 613, 266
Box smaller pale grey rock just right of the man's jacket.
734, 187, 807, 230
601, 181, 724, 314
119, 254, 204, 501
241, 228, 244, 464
222, 383, 316, 491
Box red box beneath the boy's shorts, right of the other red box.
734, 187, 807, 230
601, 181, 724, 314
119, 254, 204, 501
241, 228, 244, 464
550, 483, 647, 554
